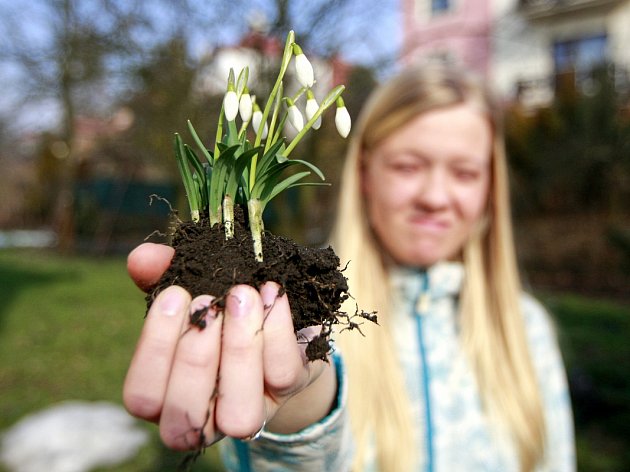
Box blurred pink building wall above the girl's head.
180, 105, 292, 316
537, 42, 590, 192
401, 0, 491, 77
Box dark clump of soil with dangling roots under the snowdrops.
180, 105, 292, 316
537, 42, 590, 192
147, 208, 376, 361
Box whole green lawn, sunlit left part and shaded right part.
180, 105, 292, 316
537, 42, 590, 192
0, 250, 630, 472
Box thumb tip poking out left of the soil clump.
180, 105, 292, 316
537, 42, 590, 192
127, 243, 175, 291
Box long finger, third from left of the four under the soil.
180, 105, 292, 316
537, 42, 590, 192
215, 285, 266, 438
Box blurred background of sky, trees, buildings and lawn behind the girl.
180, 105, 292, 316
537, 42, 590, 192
0, 0, 630, 472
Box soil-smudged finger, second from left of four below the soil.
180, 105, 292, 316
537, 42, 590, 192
160, 295, 223, 450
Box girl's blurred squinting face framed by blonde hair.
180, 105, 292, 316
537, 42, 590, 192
362, 104, 492, 267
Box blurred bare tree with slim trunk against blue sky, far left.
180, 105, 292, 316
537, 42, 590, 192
0, 0, 239, 251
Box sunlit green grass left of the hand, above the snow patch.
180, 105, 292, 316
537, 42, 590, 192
0, 250, 222, 472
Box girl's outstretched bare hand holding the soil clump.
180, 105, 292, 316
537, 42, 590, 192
123, 243, 336, 450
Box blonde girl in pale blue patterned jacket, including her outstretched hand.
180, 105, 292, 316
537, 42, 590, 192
124, 64, 575, 472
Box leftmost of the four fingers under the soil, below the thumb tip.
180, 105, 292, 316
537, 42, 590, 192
123, 286, 190, 421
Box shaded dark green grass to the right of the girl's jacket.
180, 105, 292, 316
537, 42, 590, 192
541, 294, 630, 472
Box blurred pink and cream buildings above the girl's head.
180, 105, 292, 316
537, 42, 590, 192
402, 0, 630, 106
